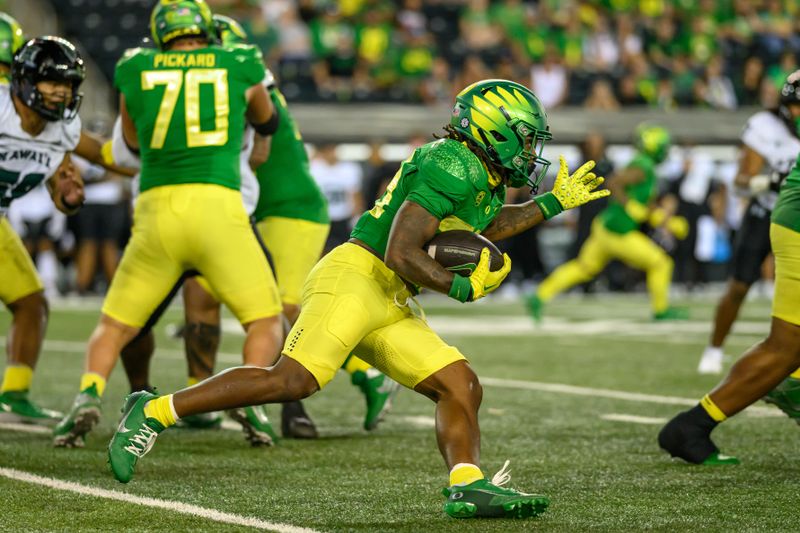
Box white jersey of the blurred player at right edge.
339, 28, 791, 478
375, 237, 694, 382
742, 111, 800, 210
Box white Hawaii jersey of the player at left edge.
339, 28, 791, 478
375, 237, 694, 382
0, 85, 81, 215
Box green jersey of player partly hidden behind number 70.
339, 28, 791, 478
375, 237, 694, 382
253, 87, 329, 224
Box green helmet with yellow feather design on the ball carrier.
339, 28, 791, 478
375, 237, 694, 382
450, 80, 553, 190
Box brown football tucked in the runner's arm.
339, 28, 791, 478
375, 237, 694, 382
427, 230, 503, 277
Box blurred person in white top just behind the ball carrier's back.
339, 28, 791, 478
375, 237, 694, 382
311, 144, 364, 251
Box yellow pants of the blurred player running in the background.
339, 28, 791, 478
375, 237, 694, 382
536, 220, 673, 313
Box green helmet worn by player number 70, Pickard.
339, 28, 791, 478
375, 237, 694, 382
150, 0, 217, 50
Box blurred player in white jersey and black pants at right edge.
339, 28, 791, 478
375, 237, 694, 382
697, 71, 800, 376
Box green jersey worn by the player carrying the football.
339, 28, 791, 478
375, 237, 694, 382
351, 139, 506, 256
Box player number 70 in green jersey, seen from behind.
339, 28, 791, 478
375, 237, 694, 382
54, 0, 282, 447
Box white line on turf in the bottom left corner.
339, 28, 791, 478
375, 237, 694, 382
0, 468, 315, 533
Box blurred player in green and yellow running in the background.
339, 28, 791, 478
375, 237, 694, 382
527, 124, 689, 322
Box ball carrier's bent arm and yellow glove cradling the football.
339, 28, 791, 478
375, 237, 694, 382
384, 200, 511, 302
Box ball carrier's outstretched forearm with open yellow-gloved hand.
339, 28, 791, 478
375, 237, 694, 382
483, 156, 609, 241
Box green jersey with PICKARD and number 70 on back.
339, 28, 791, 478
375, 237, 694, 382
114, 45, 265, 191
